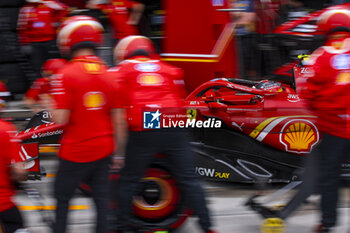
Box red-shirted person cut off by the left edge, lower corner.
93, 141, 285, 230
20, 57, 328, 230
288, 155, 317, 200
0, 100, 27, 233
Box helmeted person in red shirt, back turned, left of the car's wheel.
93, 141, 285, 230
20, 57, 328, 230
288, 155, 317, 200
51, 16, 120, 233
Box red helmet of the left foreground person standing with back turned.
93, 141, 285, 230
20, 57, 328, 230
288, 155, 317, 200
57, 15, 103, 54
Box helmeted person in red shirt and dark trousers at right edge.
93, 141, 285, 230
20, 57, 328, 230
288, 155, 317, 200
301, 7, 350, 233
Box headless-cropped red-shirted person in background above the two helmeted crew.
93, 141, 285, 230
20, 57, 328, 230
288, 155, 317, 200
89, 0, 138, 42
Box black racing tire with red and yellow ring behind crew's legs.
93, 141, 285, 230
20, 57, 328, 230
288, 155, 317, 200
79, 166, 192, 230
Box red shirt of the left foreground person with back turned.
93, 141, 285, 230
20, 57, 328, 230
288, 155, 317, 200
52, 55, 114, 162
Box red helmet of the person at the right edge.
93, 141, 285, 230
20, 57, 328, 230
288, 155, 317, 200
317, 7, 350, 34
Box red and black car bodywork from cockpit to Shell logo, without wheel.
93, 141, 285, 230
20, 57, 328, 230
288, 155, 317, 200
187, 75, 321, 182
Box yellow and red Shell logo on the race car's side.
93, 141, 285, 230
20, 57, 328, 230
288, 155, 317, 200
280, 119, 320, 153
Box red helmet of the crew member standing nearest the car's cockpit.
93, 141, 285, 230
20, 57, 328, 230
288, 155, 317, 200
113, 36, 158, 64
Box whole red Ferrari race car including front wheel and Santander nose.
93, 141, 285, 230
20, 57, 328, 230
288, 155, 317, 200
10, 61, 350, 229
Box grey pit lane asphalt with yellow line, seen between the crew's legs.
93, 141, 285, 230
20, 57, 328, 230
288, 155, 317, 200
7, 105, 350, 233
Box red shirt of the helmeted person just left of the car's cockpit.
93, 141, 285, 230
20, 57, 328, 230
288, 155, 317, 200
116, 51, 185, 131
